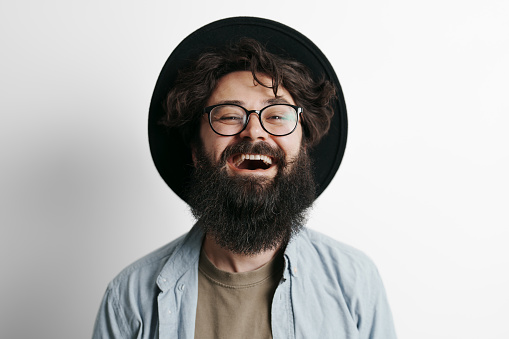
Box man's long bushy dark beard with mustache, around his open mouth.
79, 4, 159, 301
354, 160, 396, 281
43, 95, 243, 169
188, 141, 315, 255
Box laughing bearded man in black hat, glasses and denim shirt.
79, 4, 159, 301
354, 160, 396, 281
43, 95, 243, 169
94, 18, 395, 339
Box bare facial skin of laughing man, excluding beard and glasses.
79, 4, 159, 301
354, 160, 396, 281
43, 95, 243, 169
200, 71, 302, 180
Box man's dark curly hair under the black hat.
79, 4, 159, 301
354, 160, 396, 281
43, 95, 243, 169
161, 38, 336, 146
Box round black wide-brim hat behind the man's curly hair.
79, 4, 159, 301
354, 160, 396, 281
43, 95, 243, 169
148, 17, 347, 205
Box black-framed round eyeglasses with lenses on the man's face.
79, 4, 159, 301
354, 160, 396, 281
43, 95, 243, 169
204, 104, 302, 136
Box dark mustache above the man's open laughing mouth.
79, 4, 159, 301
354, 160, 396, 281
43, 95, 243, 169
220, 140, 288, 168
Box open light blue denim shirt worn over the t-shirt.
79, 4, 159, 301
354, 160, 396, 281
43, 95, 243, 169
93, 224, 396, 339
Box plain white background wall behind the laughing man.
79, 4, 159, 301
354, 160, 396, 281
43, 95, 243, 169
0, 0, 509, 339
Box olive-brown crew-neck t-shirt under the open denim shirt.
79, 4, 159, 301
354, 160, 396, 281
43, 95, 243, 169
194, 251, 284, 339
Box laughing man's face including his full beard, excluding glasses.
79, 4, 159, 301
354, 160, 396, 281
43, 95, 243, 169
188, 72, 315, 255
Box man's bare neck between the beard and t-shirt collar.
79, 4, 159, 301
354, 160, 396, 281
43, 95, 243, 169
202, 235, 279, 273
